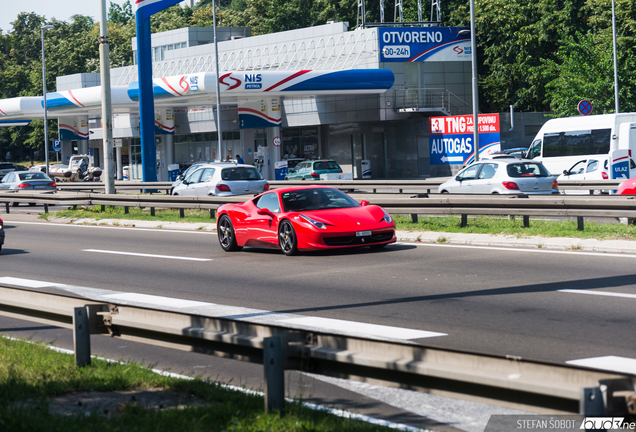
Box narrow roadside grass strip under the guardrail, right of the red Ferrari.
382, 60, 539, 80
393, 215, 636, 240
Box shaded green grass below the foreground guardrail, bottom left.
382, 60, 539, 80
0, 338, 396, 432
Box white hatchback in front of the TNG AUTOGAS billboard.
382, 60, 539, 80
437, 158, 559, 195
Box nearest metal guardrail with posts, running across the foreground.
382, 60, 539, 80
0, 283, 636, 415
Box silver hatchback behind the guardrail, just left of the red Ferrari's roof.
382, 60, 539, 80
172, 162, 269, 196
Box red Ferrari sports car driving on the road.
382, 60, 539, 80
217, 186, 395, 255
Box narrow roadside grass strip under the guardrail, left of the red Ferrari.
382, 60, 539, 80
45, 206, 216, 223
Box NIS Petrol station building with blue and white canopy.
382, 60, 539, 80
0, 22, 492, 180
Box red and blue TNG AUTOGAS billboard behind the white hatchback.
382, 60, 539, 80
429, 114, 501, 165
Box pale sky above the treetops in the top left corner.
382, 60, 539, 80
0, 0, 132, 34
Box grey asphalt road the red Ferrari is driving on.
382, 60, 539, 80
0, 214, 636, 430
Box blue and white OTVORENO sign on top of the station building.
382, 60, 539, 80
378, 27, 472, 62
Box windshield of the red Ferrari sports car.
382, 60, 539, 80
281, 188, 360, 212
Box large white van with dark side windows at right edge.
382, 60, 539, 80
527, 113, 636, 177
